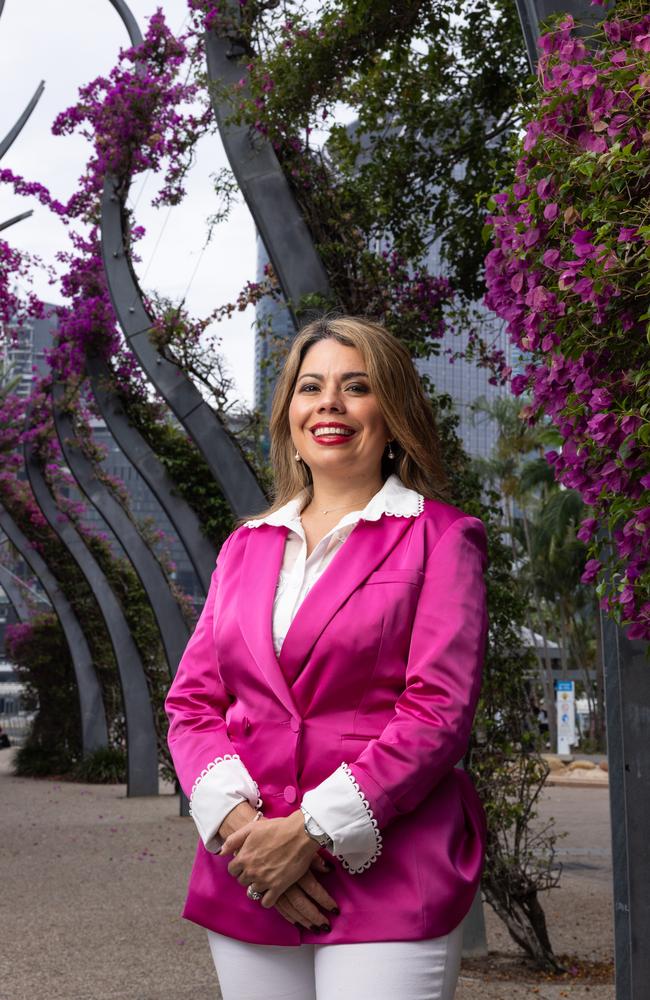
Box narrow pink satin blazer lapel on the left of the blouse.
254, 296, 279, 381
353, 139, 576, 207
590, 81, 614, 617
237, 524, 298, 715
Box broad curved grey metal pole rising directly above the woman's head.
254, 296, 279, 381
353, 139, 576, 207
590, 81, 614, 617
205, 16, 333, 323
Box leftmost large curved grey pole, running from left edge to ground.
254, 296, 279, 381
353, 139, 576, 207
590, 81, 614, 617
0, 505, 108, 753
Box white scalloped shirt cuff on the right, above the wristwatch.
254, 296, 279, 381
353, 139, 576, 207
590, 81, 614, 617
302, 762, 382, 875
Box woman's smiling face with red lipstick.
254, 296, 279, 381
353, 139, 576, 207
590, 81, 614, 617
289, 339, 391, 479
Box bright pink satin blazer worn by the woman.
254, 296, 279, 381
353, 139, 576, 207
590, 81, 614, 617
166, 500, 488, 945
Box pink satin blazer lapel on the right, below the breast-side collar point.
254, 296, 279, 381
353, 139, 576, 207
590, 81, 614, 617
279, 517, 413, 684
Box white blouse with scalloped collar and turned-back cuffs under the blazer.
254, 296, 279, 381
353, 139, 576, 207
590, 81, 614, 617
190, 474, 424, 873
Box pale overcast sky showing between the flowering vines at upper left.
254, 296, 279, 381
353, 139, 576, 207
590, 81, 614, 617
0, 0, 255, 405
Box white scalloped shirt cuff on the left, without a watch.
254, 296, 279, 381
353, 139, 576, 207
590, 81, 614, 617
190, 753, 262, 854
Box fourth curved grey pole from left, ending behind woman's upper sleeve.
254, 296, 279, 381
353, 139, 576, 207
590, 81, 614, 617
86, 357, 217, 595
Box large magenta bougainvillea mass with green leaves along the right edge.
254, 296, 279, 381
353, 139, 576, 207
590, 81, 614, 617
485, 3, 650, 639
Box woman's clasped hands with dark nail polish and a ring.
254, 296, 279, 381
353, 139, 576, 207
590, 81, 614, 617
219, 810, 338, 930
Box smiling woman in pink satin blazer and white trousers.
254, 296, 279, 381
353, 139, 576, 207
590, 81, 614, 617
166, 316, 487, 1000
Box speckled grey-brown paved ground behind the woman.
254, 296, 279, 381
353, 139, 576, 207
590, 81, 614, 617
0, 750, 614, 1000
